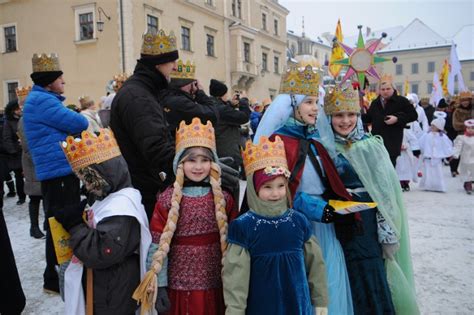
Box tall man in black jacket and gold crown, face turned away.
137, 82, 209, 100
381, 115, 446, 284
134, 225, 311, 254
110, 31, 178, 219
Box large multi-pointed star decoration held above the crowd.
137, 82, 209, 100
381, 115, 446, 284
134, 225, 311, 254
333, 25, 397, 87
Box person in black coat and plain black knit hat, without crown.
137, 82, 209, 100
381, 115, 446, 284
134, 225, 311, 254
209, 79, 250, 171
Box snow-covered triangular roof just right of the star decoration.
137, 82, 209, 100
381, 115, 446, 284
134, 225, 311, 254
380, 18, 450, 53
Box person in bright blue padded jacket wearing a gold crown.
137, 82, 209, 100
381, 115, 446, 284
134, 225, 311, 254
23, 54, 88, 292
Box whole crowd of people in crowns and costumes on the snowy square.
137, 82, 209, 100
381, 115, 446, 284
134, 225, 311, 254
0, 27, 474, 315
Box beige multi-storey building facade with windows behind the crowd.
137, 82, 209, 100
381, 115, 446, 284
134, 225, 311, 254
0, 0, 289, 106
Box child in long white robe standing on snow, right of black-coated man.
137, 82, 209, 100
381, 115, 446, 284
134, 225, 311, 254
419, 112, 453, 192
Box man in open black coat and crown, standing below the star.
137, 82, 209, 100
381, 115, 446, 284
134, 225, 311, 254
362, 75, 418, 166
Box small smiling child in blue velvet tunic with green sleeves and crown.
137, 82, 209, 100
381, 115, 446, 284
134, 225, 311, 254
223, 136, 328, 315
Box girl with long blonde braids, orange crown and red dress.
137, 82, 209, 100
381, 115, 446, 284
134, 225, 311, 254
134, 118, 237, 315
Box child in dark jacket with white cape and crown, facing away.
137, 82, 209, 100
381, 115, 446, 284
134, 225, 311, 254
55, 129, 151, 315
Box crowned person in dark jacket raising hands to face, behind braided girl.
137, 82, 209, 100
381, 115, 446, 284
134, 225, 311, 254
160, 60, 217, 136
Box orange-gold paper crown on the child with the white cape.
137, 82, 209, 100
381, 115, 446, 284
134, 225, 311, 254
61, 128, 121, 171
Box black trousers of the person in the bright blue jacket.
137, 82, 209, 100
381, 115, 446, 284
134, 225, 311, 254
41, 174, 81, 287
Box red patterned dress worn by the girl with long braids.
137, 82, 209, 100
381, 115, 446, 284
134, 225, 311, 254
149, 187, 237, 315
